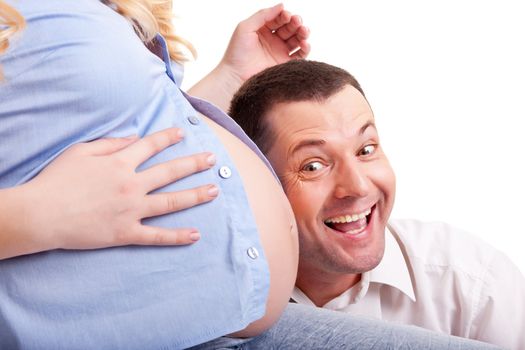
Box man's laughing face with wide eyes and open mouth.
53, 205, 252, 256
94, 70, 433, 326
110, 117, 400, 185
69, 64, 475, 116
266, 85, 395, 274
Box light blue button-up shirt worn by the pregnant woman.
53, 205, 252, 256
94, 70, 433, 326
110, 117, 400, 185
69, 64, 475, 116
0, 0, 269, 350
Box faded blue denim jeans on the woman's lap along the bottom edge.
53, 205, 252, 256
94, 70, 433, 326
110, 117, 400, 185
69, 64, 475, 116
192, 304, 499, 350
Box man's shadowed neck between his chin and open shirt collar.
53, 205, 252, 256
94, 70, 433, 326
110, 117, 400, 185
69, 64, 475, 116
295, 264, 361, 307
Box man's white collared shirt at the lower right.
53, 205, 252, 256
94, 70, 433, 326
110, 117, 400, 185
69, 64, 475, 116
292, 220, 525, 350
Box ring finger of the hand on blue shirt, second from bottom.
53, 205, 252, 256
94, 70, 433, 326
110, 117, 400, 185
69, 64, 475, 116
142, 185, 219, 217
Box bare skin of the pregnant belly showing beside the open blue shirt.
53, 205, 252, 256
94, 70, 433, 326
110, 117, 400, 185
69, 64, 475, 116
202, 116, 298, 337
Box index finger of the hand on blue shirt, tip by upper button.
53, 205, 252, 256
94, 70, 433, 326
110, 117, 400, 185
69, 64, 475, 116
118, 128, 184, 166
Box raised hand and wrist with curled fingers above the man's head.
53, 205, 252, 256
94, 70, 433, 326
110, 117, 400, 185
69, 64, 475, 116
188, 4, 310, 110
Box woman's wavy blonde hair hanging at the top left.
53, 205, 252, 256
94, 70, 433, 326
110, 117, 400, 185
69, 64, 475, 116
0, 0, 197, 79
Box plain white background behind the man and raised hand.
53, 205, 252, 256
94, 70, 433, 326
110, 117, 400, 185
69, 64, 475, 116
174, 0, 525, 272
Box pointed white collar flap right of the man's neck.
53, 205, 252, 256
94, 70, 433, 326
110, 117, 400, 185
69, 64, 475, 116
369, 227, 416, 301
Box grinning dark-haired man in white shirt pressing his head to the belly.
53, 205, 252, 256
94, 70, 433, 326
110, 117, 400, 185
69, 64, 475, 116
230, 60, 525, 349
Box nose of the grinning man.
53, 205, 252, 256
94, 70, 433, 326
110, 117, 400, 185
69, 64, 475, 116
334, 161, 371, 199
